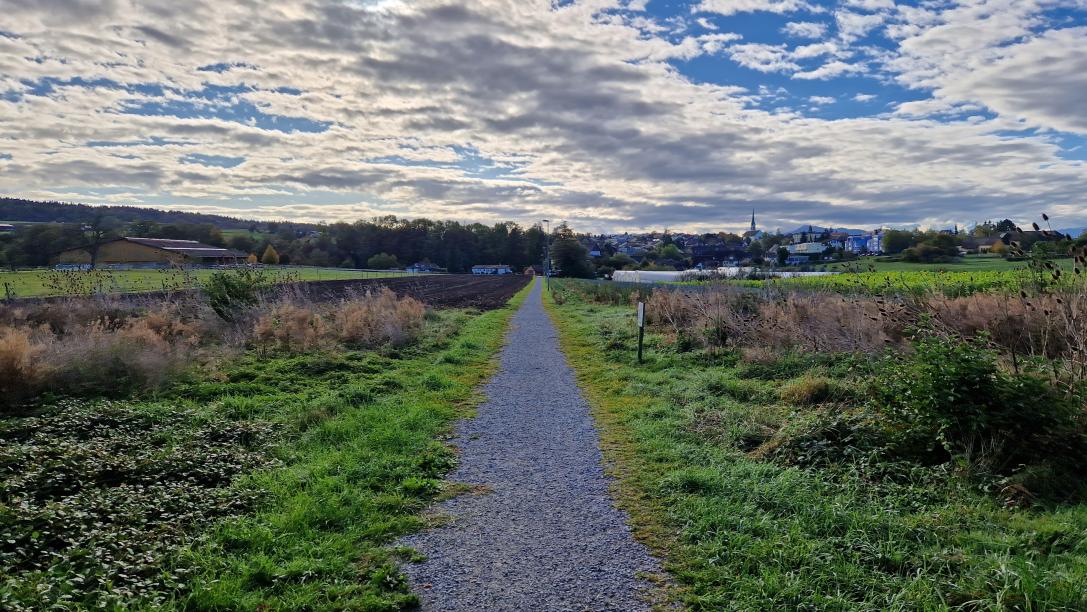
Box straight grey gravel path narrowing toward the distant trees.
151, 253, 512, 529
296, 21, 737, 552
403, 282, 660, 611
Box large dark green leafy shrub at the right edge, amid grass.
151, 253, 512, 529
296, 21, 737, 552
872, 334, 1087, 486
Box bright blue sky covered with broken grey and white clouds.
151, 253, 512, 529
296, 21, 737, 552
0, 0, 1087, 232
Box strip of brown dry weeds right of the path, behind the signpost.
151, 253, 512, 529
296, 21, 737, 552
647, 285, 1087, 379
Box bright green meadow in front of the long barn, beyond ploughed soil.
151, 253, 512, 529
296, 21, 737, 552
0, 266, 404, 298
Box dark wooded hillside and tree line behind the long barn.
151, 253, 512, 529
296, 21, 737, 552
0, 199, 545, 273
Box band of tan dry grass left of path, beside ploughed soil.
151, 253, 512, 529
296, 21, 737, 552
0, 289, 426, 410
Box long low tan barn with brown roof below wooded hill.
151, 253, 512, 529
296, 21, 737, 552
53, 238, 249, 267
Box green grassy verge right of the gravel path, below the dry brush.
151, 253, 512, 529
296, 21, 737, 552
546, 289, 1087, 610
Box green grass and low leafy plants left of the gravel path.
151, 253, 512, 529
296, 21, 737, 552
0, 290, 527, 610
